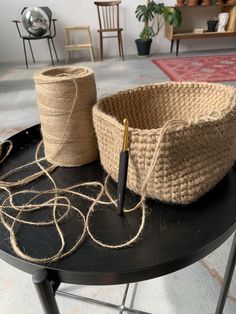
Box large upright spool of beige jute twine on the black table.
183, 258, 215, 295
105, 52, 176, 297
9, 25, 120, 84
34, 67, 98, 167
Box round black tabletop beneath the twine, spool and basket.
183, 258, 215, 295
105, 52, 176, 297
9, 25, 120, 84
0, 125, 236, 285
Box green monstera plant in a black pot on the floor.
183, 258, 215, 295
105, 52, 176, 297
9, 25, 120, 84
135, 0, 182, 56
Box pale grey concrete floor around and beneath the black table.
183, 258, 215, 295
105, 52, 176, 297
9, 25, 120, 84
0, 51, 236, 314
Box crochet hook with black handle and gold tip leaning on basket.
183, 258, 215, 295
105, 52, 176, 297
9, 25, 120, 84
117, 119, 129, 215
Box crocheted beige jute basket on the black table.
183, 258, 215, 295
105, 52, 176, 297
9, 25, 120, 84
93, 82, 236, 204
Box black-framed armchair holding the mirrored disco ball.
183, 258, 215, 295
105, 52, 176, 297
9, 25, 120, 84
12, 7, 59, 69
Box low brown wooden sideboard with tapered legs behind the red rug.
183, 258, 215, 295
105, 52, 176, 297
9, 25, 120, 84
165, 4, 236, 56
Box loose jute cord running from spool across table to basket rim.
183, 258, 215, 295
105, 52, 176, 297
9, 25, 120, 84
0, 78, 223, 264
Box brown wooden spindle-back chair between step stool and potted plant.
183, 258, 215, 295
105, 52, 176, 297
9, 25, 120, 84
94, 1, 124, 61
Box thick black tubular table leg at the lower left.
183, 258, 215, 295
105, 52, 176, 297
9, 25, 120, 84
32, 269, 60, 314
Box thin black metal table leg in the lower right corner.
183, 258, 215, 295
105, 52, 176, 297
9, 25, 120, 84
215, 231, 236, 314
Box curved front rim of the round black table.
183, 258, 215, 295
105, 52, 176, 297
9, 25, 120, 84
0, 223, 236, 285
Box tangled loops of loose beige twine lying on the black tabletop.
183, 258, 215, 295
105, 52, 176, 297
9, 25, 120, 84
0, 141, 146, 264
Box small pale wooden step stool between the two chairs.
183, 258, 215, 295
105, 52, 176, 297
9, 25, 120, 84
65, 26, 94, 63
